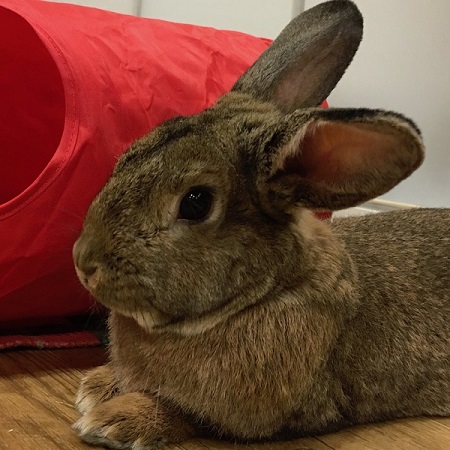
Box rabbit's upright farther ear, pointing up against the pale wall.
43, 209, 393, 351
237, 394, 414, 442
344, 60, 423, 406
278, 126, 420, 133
233, 0, 363, 113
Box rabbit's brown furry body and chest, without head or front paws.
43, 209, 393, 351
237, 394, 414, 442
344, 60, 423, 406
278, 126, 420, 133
102, 210, 450, 439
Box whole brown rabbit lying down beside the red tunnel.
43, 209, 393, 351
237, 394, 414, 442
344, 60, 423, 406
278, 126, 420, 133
73, 0, 450, 450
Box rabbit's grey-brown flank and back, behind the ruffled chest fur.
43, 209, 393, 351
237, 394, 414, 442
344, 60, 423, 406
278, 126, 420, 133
331, 209, 450, 421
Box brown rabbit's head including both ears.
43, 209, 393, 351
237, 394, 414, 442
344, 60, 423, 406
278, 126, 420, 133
74, 0, 423, 333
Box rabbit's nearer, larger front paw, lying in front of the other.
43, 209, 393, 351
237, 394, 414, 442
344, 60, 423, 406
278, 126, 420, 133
73, 393, 192, 450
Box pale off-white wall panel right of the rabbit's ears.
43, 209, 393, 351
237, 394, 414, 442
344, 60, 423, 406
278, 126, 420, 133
305, 0, 450, 206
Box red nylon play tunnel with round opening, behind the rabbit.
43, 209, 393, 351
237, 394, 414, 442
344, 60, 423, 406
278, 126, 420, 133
0, 0, 270, 328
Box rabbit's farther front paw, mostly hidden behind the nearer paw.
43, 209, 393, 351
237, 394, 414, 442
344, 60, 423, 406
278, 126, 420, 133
75, 365, 118, 415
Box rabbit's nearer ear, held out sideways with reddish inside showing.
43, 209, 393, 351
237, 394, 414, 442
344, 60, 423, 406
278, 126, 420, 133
256, 109, 423, 213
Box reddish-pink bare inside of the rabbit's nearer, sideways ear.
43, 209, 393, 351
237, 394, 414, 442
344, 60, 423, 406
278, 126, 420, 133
283, 122, 402, 185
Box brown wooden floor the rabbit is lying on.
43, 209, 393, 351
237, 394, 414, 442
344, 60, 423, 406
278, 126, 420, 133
0, 348, 450, 450
